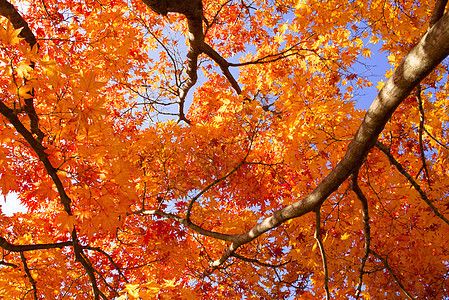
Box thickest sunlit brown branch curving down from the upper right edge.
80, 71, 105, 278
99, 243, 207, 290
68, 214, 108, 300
209, 9, 449, 265
